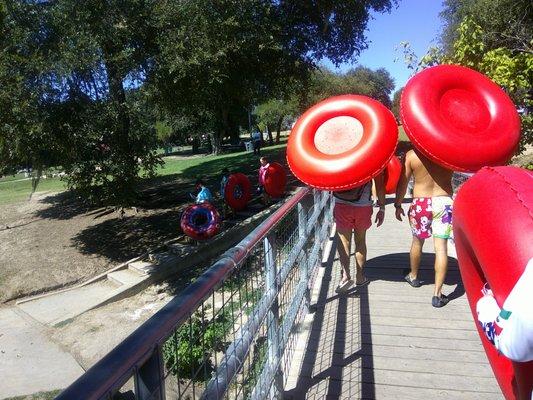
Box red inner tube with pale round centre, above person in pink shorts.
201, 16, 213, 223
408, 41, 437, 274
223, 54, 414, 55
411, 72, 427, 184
287, 95, 398, 190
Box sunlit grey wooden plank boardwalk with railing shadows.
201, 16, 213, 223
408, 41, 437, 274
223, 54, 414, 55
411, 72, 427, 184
284, 206, 503, 400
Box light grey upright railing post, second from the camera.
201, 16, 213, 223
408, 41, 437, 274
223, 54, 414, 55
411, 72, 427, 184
263, 231, 283, 399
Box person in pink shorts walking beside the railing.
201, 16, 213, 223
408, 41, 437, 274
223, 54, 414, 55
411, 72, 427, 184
333, 174, 385, 293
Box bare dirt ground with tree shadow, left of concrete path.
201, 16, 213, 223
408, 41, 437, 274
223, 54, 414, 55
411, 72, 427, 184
0, 193, 186, 302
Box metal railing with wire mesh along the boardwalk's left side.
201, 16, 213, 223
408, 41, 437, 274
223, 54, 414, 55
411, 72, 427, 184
58, 188, 333, 400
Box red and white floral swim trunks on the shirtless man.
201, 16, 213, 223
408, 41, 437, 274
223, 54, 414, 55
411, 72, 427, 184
409, 196, 453, 239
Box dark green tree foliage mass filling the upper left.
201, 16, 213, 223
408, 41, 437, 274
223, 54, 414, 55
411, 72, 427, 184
0, 0, 396, 206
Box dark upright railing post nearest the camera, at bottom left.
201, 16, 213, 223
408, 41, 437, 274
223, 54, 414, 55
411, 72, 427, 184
135, 346, 165, 400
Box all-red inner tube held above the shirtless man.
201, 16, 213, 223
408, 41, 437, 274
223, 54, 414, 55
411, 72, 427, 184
400, 65, 520, 172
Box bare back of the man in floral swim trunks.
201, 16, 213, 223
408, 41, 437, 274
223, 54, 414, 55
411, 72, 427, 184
405, 150, 453, 197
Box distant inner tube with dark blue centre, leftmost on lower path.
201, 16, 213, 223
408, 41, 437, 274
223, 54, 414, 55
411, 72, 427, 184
180, 203, 220, 240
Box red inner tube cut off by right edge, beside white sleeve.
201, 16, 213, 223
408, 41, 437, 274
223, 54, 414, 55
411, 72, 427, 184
453, 167, 533, 400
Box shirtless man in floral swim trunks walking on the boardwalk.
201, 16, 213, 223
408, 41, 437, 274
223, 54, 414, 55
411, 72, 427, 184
394, 150, 453, 307
